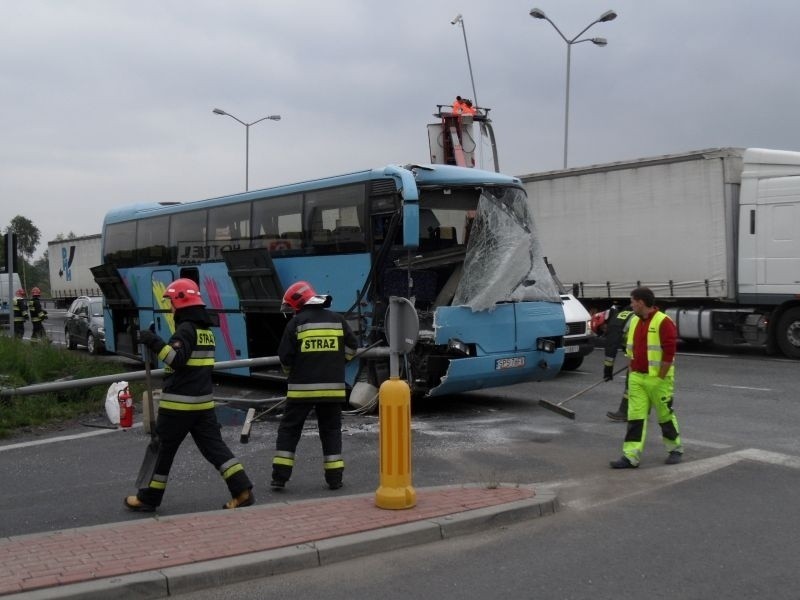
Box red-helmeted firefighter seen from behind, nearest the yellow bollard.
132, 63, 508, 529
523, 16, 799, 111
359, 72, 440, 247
271, 281, 358, 490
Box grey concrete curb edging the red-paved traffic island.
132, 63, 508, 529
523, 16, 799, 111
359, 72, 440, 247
3, 484, 559, 600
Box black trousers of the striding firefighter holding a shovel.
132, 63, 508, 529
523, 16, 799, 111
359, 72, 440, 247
138, 409, 253, 506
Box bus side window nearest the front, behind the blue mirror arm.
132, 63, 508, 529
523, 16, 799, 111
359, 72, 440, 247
305, 184, 367, 254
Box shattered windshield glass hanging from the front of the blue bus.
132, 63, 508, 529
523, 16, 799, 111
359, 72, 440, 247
453, 187, 560, 311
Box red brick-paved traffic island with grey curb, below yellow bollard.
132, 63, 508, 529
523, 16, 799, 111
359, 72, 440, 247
0, 484, 558, 600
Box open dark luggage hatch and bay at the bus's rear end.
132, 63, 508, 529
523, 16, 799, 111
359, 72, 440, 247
90, 264, 140, 358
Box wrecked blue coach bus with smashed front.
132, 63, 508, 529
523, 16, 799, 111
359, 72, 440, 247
93, 165, 565, 396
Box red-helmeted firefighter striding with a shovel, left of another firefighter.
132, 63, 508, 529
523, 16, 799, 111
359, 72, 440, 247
125, 279, 255, 512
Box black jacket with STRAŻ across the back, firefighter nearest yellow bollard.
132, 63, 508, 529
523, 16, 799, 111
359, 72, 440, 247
278, 306, 358, 403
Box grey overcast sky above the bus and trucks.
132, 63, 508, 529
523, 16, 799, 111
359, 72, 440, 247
0, 0, 800, 256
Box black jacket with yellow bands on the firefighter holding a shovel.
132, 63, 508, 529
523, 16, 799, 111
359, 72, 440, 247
150, 306, 216, 411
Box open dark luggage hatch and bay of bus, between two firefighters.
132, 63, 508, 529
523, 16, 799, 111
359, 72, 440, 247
222, 248, 288, 380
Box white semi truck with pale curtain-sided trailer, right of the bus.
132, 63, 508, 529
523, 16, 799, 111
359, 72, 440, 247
520, 148, 800, 358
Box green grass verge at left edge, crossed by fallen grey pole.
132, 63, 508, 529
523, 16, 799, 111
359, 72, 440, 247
0, 335, 141, 438
